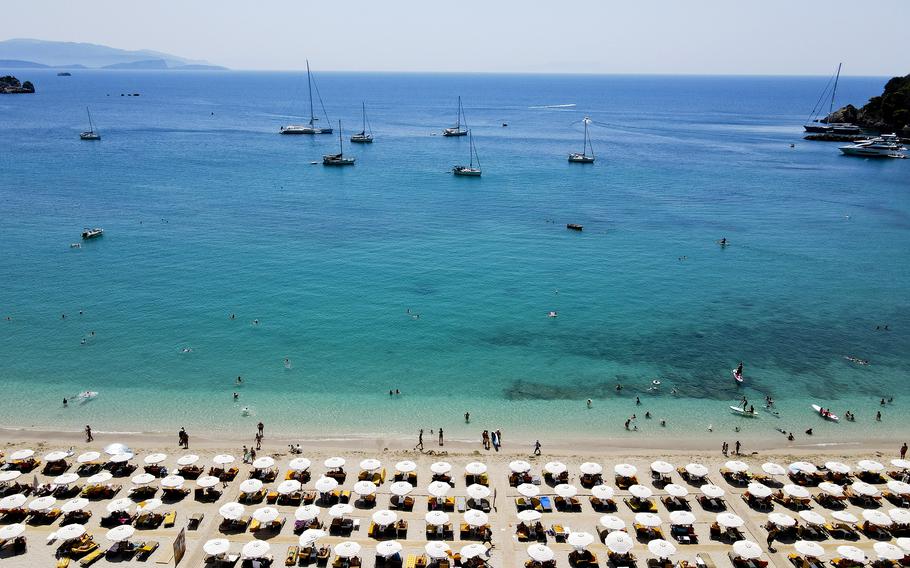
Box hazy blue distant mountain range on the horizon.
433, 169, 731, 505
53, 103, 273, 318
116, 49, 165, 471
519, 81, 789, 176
0, 39, 227, 70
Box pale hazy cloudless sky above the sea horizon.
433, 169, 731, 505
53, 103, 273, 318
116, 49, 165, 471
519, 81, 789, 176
0, 0, 910, 75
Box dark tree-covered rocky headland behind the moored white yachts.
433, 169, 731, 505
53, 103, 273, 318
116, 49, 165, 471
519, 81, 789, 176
825, 75, 910, 136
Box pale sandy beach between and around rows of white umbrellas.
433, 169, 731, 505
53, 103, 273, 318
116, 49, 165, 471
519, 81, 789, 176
2, 430, 910, 567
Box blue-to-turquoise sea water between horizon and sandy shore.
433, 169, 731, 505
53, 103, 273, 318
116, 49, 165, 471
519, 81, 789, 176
0, 71, 910, 441
